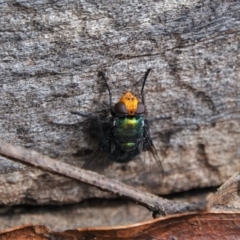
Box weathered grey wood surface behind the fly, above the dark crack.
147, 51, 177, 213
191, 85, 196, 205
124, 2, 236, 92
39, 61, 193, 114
0, 0, 240, 204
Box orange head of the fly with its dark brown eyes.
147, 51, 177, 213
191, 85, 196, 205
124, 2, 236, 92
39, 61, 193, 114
114, 92, 145, 115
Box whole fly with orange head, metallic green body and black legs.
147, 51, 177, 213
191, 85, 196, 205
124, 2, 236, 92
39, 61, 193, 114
72, 69, 163, 186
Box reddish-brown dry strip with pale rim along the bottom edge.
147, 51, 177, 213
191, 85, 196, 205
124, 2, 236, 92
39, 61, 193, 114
0, 211, 240, 240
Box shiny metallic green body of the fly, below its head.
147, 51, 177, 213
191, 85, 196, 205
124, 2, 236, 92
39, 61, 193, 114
113, 116, 144, 151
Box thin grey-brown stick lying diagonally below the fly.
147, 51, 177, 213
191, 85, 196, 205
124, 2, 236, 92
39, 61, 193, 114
0, 140, 204, 215
